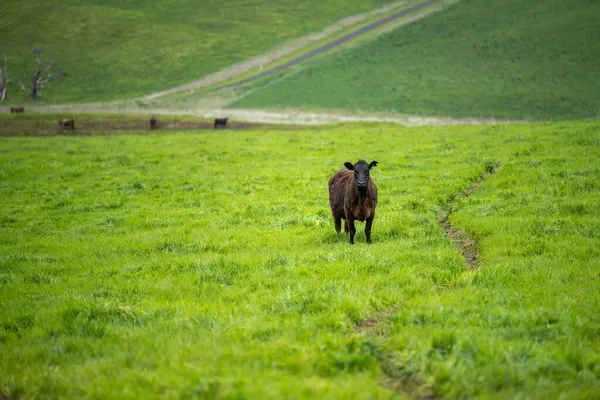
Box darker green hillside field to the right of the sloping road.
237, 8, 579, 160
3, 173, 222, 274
235, 0, 600, 119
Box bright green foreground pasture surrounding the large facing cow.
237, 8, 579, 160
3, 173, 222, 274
0, 119, 600, 399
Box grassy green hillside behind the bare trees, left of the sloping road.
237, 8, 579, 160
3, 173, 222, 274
0, 0, 389, 102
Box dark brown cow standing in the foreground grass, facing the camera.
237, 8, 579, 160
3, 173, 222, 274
329, 160, 377, 244
